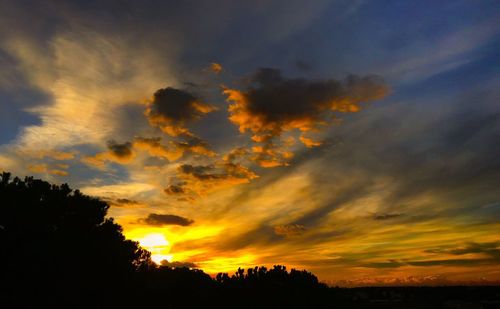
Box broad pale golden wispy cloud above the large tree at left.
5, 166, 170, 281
0, 27, 173, 149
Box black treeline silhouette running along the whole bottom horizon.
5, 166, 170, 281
0, 172, 500, 308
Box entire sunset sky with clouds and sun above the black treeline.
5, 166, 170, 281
0, 0, 500, 286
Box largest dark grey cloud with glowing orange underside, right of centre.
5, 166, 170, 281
223, 68, 388, 167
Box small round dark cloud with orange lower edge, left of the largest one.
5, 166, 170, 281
145, 87, 215, 136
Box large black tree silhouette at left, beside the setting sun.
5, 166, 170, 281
0, 173, 151, 304
